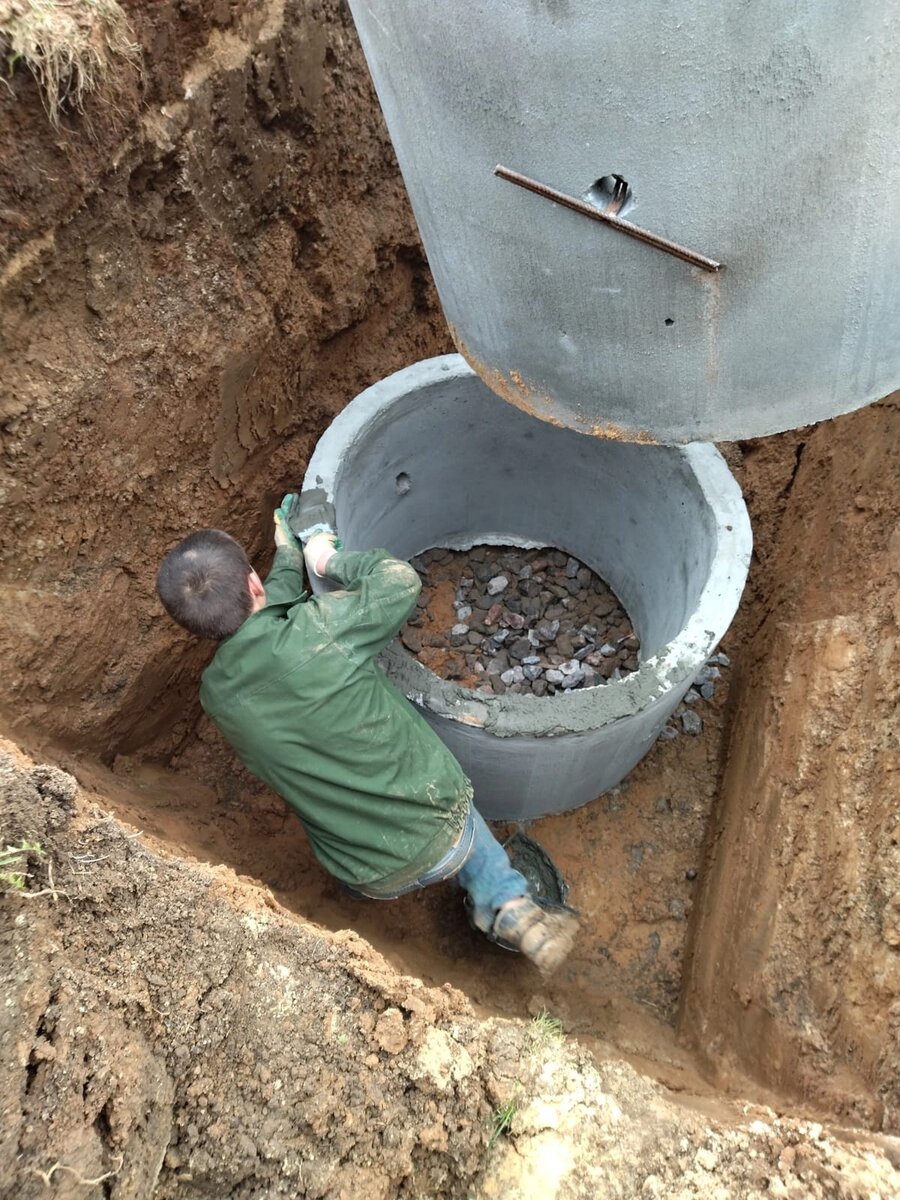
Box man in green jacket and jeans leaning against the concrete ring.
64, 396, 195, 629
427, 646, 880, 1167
157, 498, 577, 973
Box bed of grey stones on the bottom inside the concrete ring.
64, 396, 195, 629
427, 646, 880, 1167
400, 546, 641, 696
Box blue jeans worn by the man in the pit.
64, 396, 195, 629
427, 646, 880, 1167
347, 804, 528, 934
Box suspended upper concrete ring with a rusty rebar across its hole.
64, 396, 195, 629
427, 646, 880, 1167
350, 0, 900, 443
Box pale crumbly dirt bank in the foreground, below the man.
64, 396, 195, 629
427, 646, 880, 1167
0, 751, 900, 1200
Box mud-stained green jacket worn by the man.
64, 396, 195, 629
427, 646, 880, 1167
200, 550, 472, 890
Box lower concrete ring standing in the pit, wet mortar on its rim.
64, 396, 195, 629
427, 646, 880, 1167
304, 354, 751, 818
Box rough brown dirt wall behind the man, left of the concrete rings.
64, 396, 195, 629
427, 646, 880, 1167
0, 0, 449, 760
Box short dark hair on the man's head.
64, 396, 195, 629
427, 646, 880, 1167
156, 529, 253, 640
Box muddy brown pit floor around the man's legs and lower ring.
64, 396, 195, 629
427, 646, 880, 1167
62, 646, 770, 1102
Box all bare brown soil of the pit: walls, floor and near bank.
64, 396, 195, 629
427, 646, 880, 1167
0, 0, 900, 1200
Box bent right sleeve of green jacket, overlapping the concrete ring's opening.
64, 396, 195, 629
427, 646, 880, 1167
316, 550, 422, 658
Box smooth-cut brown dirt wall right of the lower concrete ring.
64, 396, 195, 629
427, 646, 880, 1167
680, 396, 900, 1130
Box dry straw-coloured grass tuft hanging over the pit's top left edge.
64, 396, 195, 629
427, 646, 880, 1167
0, 0, 140, 125
